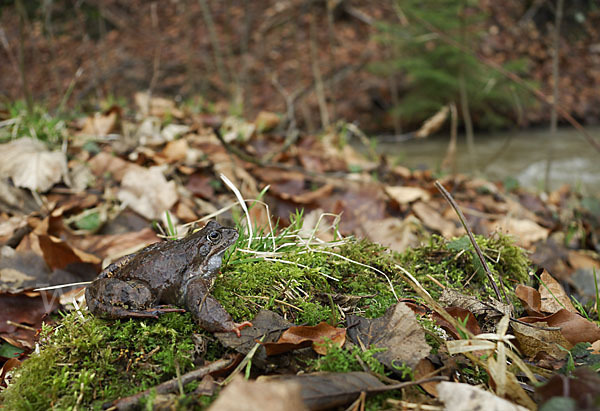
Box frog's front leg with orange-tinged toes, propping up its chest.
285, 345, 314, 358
184, 277, 252, 337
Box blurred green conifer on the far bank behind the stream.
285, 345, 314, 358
371, 0, 531, 127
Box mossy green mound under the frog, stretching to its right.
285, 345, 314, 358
2, 236, 528, 409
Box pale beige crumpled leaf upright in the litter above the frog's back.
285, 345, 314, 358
118, 167, 177, 220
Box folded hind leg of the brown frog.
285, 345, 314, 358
85, 278, 185, 319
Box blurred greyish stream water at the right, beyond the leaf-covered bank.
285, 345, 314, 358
377, 127, 600, 194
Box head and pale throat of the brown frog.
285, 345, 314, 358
194, 221, 238, 278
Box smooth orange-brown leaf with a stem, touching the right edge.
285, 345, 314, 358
519, 309, 600, 345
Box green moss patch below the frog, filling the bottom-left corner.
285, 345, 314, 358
3, 312, 204, 410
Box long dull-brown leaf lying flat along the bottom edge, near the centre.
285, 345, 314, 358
258, 372, 385, 410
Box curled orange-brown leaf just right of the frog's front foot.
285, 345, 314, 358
262, 322, 346, 355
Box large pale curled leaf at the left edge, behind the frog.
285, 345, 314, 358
0, 138, 68, 192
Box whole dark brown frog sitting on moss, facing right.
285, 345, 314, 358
85, 221, 252, 337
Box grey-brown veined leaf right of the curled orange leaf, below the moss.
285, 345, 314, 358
346, 303, 431, 369
